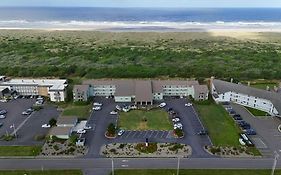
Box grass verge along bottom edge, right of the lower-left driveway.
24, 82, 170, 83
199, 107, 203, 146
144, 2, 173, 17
110, 169, 281, 175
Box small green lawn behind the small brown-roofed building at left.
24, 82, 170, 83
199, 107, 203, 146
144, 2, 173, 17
62, 104, 92, 119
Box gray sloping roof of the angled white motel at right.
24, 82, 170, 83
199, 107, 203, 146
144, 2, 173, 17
213, 79, 281, 113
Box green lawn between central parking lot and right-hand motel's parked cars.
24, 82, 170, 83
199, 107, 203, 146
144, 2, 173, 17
195, 103, 240, 146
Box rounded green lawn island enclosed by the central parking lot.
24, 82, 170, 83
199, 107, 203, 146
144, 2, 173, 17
118, 109, 173, 130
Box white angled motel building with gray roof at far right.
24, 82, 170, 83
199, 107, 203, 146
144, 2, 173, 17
211, 77, 281, 117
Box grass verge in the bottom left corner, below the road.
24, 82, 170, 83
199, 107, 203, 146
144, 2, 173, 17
0, 170, 83, 175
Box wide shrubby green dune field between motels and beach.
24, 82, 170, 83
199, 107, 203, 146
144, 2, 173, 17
0, 30, 281, 80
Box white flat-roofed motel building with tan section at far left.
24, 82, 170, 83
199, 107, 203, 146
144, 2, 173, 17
0, 76, 68, 102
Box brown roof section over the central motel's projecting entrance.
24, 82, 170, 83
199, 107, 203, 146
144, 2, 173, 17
135, 80, 153, 102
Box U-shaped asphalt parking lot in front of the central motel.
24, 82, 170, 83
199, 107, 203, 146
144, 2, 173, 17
86, 98, 211, 157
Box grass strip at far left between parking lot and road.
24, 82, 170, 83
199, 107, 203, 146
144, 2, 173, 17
0, 146, 41, 156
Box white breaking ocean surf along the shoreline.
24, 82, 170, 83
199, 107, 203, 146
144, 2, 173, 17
0, 20, 281, 29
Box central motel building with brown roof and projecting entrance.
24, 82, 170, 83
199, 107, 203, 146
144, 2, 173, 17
73, 79, 209, 105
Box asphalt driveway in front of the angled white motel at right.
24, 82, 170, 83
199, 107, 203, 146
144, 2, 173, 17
232, 104, 281, 156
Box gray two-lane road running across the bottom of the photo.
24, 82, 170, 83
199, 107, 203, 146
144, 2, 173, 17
0, 158, 276, 170
